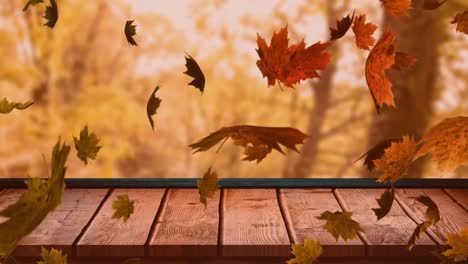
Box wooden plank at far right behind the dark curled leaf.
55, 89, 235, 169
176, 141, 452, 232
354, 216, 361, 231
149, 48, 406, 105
397, 189, 468, 245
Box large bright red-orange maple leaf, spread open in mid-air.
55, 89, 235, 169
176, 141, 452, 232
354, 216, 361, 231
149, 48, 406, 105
257, 27, 333, 87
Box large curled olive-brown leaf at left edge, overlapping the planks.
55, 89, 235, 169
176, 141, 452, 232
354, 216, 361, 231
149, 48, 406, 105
0, 139, 70, 256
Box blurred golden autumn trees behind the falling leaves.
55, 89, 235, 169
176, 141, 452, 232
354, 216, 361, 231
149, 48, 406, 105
0, 0, 468, 178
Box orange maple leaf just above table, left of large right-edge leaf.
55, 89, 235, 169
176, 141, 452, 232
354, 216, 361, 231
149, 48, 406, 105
374, 136, 416, 184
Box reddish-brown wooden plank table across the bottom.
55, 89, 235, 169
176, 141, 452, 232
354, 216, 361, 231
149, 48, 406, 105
0, 180, 468, 263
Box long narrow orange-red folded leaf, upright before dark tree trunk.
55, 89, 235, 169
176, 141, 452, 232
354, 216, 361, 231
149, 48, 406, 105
365, 29, 395, 112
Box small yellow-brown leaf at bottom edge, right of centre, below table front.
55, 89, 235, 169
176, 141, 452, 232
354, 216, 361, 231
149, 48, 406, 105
287, 238, 323, 264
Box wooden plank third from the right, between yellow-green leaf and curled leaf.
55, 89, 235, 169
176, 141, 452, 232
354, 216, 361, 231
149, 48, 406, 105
335, 189, 437, 257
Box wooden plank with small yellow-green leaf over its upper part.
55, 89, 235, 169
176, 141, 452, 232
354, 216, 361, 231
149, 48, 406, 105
76, 189, 165, 257
